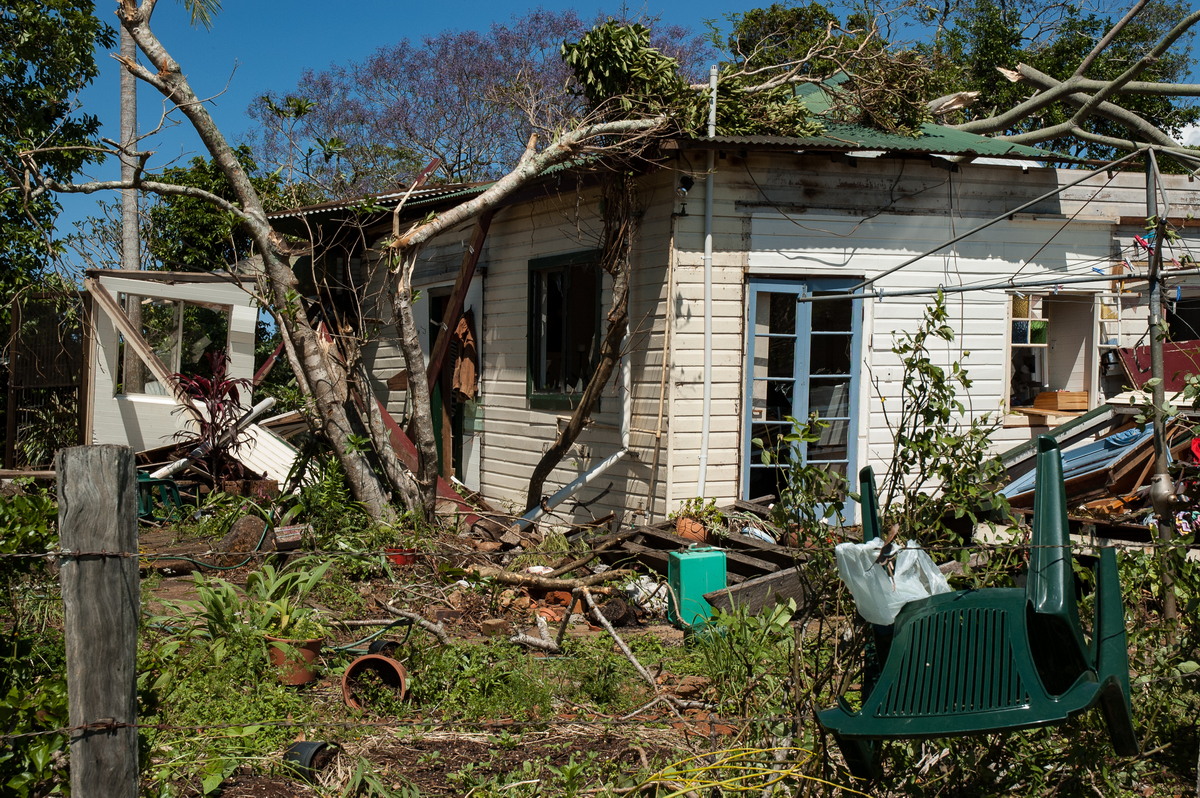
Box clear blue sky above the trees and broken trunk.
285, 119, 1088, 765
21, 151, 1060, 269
68, 0, 769, 218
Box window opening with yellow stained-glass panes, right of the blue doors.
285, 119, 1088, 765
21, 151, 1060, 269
1008, 293, 1096, 412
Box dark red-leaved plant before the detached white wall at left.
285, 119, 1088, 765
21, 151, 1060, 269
174, 352, 252, 482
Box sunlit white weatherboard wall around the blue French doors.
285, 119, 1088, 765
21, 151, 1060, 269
667, 152, 1200, 508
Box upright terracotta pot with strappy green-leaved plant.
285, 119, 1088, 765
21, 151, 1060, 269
246, 560, 330, 684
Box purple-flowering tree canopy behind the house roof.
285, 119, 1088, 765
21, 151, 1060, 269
250, 10, 712, 196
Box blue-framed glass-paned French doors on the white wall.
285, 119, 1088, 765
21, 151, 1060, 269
742, 277, 863, 521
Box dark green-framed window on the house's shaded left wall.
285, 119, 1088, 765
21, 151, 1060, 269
526, 250, 604, 410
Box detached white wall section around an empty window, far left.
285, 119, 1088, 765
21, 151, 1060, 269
89, 276, 258, 451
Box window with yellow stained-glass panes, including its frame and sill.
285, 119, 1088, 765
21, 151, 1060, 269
1004, 292, 1100, 426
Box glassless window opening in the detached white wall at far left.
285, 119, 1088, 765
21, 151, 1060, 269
116, 294, 230, 395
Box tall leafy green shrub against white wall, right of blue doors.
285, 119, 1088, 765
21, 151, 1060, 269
880, 292, 1008, 542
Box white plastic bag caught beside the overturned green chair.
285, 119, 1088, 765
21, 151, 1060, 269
834, 538, 950, 626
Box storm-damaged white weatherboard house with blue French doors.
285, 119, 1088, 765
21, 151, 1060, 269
274, 126, 1200, 523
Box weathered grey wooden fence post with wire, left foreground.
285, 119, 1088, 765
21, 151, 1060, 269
56, 445, 140, 798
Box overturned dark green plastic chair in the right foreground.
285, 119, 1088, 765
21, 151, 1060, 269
820, 436, 1139, 779
